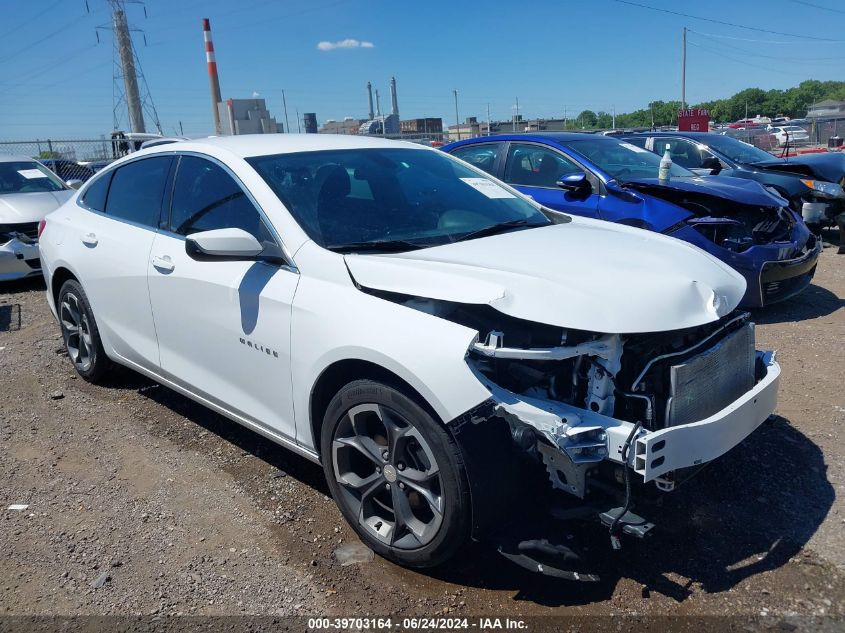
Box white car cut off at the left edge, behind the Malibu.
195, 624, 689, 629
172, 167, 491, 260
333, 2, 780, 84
0, 156, 73, 282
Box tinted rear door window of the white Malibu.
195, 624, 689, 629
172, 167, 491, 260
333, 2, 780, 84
106, 156, 172, 227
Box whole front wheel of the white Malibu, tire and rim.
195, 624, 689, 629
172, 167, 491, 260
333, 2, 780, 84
321, 380, 471, 567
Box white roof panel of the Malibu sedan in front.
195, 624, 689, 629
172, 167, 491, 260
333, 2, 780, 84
138, 134, 436, 158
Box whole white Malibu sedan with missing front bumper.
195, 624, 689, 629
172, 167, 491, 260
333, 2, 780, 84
40, 135, 780, 567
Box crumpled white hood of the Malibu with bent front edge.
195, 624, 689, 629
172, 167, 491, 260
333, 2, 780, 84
345, 218, 746, 336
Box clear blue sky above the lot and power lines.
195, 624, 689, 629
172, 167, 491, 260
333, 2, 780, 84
0, 0, 845, 140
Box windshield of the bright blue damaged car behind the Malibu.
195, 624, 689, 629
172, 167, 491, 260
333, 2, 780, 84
566, 136, 695, 183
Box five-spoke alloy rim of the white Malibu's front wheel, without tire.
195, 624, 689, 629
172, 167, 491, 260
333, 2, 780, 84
332, 404, 444, 549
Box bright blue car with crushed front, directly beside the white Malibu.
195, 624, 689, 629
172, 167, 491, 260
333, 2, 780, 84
443, 132, 822, 308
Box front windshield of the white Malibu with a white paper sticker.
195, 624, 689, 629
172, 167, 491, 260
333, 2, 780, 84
247, 148, 550, 251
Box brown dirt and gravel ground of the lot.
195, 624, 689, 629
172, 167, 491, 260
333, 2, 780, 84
0, 236, 845, 620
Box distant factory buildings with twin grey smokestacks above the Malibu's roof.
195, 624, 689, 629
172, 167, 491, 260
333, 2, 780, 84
314, 77, 443, 136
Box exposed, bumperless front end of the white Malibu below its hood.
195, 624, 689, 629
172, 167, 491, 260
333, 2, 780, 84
376, 293, 780, 556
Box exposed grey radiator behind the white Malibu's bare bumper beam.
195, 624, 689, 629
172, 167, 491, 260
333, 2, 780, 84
666, 323, 756, 426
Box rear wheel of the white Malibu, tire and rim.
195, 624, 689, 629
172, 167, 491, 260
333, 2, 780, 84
56, 279, 112, 383
